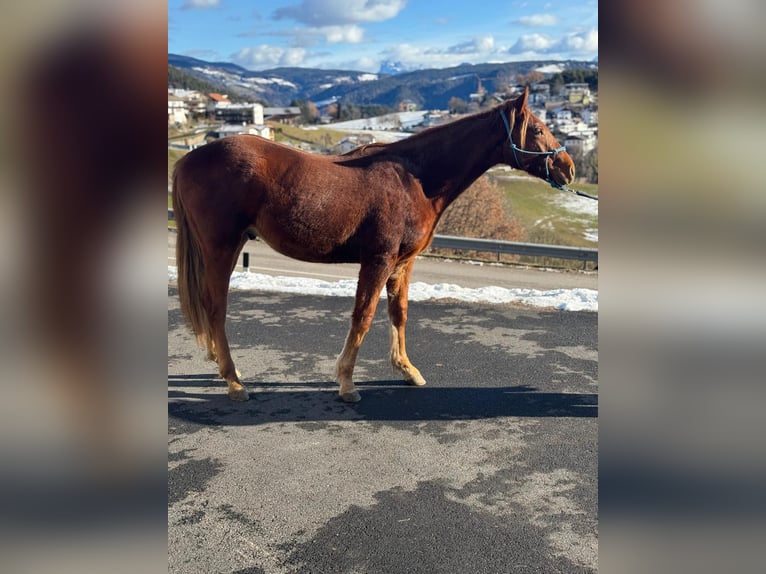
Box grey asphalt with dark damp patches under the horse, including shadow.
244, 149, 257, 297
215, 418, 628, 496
168, 274, 598, 574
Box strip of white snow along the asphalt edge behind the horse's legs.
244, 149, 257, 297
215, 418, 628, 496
168, 265, 598, 311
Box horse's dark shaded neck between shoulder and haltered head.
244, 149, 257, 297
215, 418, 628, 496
405, 114, 502, 212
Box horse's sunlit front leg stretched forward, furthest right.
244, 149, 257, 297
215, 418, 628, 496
386, 258, 426, 386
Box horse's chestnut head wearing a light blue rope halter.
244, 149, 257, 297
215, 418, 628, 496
500, 88, 575, 186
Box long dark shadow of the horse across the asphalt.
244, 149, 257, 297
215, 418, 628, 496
168, 375, 598, 426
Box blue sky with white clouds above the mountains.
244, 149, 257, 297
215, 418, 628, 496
168, 0, 598, 73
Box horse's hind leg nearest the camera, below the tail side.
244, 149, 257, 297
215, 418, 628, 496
206, 238, 250, 401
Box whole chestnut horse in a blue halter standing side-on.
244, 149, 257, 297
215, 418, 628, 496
172, 88, 574, 402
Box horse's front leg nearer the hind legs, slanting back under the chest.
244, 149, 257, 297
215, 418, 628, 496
335, 259, 393, 403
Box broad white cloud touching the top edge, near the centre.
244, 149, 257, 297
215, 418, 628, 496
274, 0, 407, 28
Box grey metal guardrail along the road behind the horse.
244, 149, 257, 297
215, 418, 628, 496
168, 209, 598, 263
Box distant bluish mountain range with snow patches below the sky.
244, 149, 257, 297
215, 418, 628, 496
168, 54, 598, 109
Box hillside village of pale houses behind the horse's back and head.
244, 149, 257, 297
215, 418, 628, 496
168, 81, 598, 170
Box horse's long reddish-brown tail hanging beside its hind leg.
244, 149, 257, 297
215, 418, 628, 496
173, 161, 212, 351
